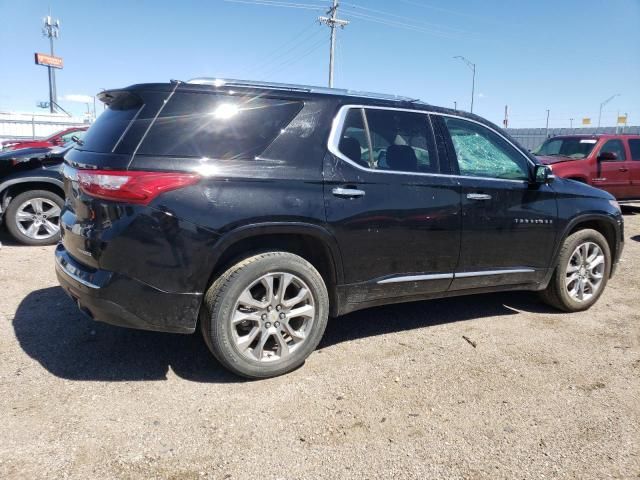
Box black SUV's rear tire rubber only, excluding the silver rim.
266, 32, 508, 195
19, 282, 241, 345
203, 252, 329, 378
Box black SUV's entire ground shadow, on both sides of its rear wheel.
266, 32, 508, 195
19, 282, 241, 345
13, 287, 555, 383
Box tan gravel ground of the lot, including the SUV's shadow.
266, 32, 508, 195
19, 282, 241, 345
0, 209, 640, 479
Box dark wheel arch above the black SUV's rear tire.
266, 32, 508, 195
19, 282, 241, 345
205, 223, 343, 315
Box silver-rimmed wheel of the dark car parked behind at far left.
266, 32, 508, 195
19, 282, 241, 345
4, 190, 64, 245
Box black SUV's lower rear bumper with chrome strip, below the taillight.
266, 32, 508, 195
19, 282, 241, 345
55, 244, 202, 333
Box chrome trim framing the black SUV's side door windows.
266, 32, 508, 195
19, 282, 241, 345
327, 104, 536, 185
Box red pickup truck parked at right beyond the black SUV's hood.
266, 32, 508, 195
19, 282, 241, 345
532, 135, 640, 202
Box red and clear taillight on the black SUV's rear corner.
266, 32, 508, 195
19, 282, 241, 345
78, 170, 200, 205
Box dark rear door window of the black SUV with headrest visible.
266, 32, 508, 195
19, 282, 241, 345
365, 109, 439, 173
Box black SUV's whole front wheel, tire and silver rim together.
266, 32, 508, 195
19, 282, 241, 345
541, 229, 611, 312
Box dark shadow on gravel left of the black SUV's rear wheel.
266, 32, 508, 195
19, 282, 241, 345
13, 287, 241, 383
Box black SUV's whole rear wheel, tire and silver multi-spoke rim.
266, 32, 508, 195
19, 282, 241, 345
200, 252, 329, 378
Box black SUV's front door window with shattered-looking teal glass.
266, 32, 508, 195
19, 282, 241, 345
445, 117, 529, 180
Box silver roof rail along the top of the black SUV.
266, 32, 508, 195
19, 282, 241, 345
187, 77, 420, 103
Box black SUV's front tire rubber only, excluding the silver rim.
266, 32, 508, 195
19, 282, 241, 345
553, 229, 611, 312
